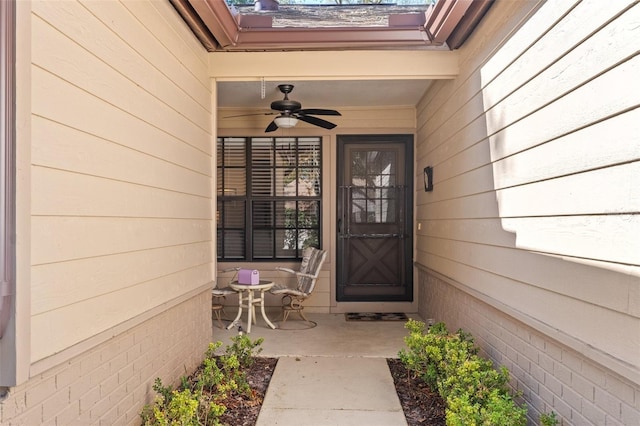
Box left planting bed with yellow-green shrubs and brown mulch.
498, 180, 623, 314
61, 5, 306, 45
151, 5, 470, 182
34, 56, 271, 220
140, 335, 277, 426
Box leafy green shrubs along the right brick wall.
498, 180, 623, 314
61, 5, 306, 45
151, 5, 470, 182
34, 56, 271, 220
398, 320, 526, 426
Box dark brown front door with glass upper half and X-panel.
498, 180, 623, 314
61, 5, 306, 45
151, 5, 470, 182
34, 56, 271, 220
336, 135, 413, 301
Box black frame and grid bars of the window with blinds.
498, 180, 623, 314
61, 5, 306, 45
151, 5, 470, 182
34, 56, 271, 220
216, 136, 323, 262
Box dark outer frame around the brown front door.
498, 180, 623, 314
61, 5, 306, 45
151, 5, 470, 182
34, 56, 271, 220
333, 133, 415, 304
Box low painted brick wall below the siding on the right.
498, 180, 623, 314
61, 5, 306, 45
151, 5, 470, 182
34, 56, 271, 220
419, 271, 640, 426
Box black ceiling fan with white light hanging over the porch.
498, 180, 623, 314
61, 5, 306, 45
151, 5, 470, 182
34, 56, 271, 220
227, 84, 342, 133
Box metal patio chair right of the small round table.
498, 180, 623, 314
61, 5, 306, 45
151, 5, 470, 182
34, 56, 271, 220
269, 247, 327, 323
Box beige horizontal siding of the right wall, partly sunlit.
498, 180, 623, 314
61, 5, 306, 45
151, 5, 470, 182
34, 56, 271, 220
416, 1, 640, 412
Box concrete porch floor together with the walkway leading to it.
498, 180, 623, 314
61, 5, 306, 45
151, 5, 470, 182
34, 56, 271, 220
213, 312, 421, 426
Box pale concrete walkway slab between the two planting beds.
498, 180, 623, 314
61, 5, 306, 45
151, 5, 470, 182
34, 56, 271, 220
256, 357, 407, 426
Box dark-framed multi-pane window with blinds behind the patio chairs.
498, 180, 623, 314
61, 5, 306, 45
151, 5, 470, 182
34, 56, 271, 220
216, 137, 322, 261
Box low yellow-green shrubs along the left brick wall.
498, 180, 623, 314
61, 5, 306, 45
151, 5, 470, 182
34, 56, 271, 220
140, 335, 263, 426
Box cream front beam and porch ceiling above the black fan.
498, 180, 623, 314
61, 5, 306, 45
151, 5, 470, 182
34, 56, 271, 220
209, 51, 459, 108
